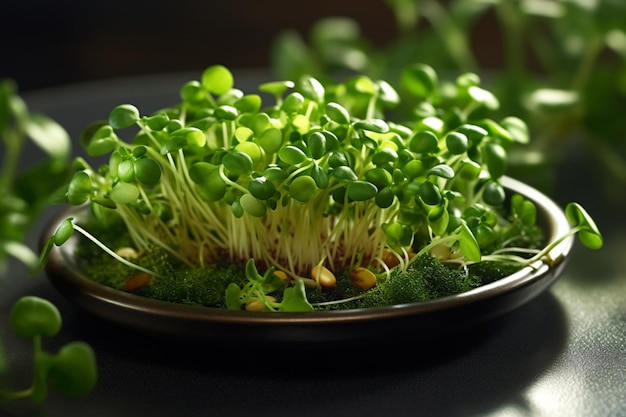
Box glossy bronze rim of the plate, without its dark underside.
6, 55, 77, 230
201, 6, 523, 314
41, 177, 574, 332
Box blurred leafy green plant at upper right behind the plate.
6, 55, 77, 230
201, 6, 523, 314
273, 0, 626, 187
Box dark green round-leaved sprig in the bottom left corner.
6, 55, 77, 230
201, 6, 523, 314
0, 296, 98, 403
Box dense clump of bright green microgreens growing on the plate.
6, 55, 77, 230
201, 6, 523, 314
42, 64, 602, 311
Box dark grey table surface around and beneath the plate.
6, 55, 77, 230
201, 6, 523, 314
0, 73, 626, 417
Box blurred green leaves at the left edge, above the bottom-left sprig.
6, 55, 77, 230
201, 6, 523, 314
0, 80, 71, 274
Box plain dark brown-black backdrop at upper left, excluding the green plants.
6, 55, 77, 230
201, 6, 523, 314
0, 0, 395, 91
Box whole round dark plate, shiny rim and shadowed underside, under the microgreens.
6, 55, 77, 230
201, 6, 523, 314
43, 178, 574, 344
